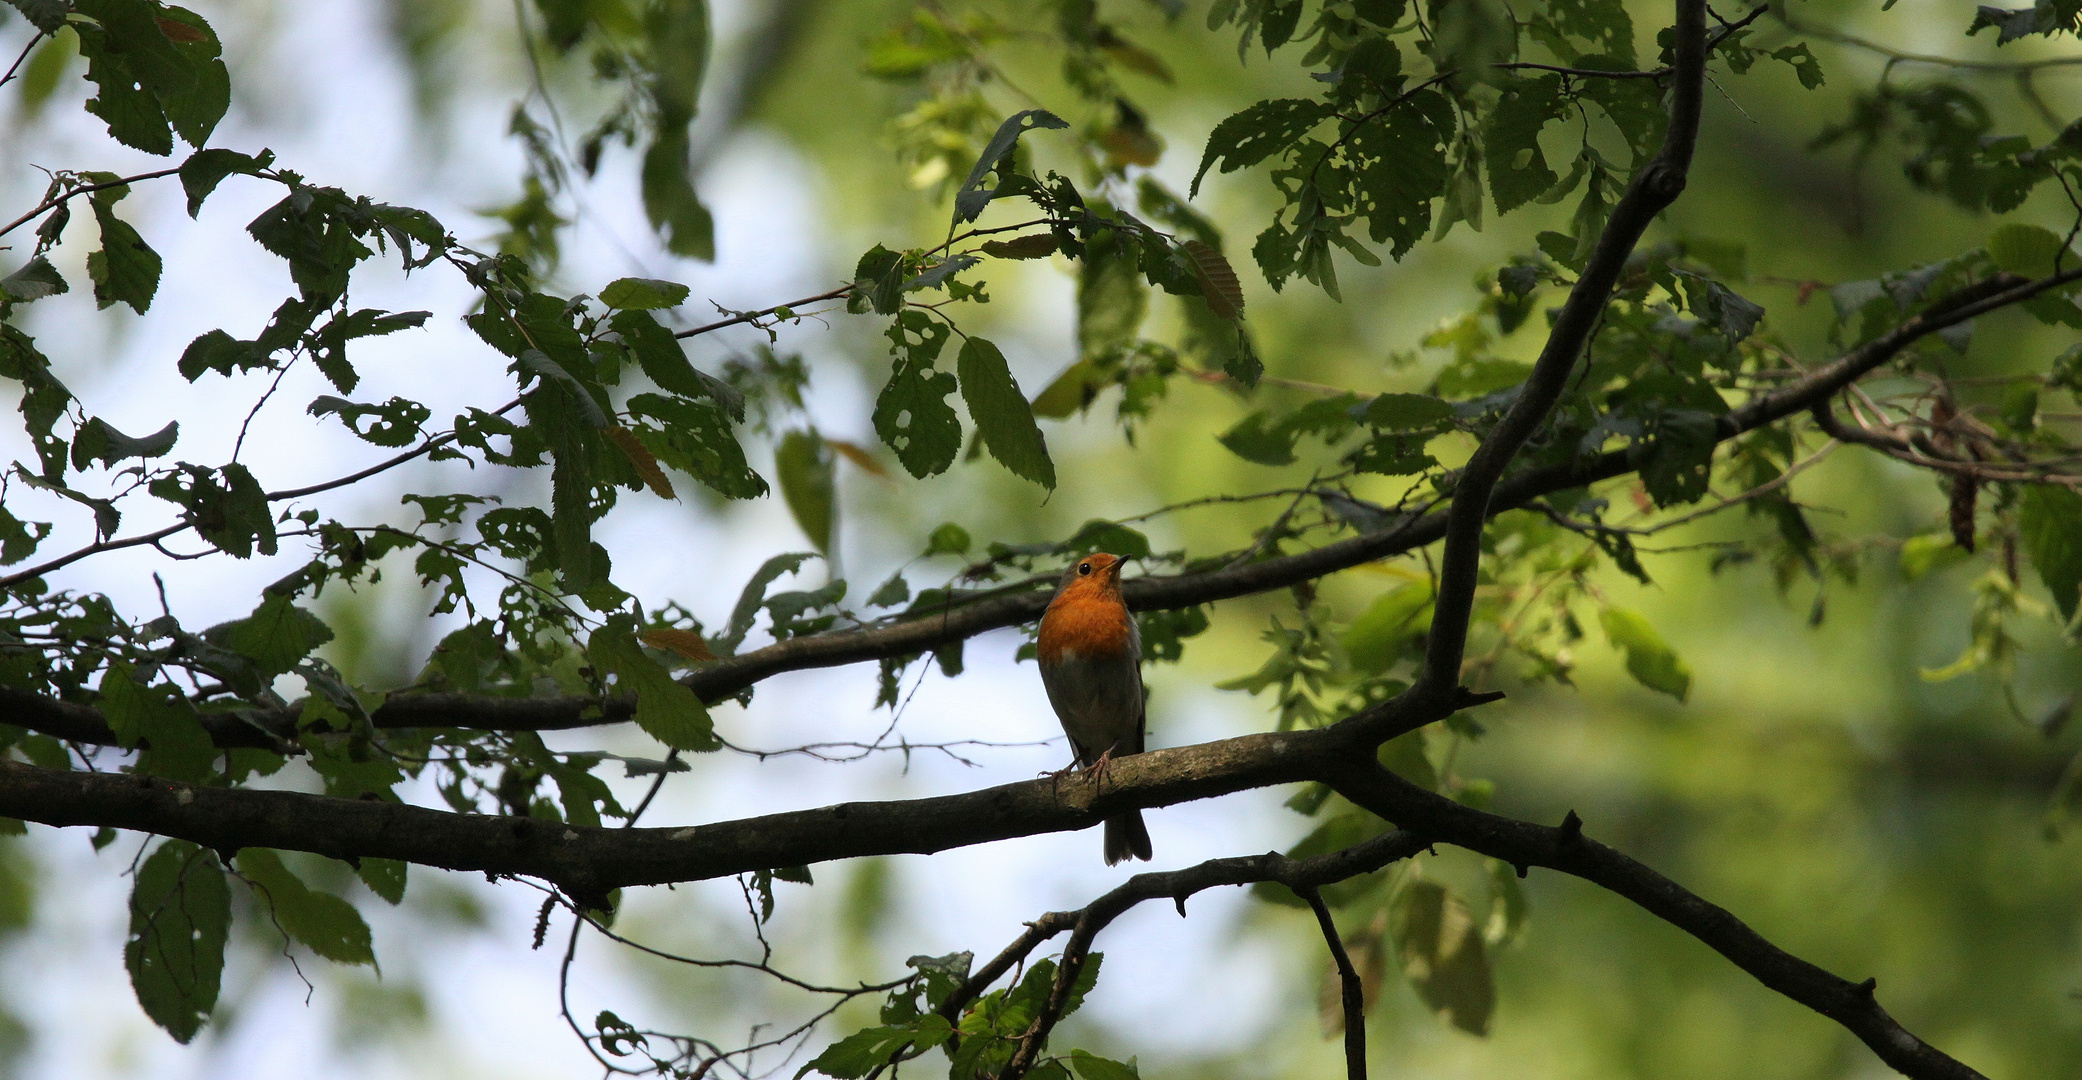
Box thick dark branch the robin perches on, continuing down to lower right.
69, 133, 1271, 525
0, 701, 1978, 1080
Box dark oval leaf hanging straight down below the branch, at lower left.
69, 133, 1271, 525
123, 841, 231, 1043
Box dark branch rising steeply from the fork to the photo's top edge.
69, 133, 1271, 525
1410, 0, 1705, 697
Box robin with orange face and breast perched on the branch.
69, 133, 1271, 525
1035, 551, 1149, 866
